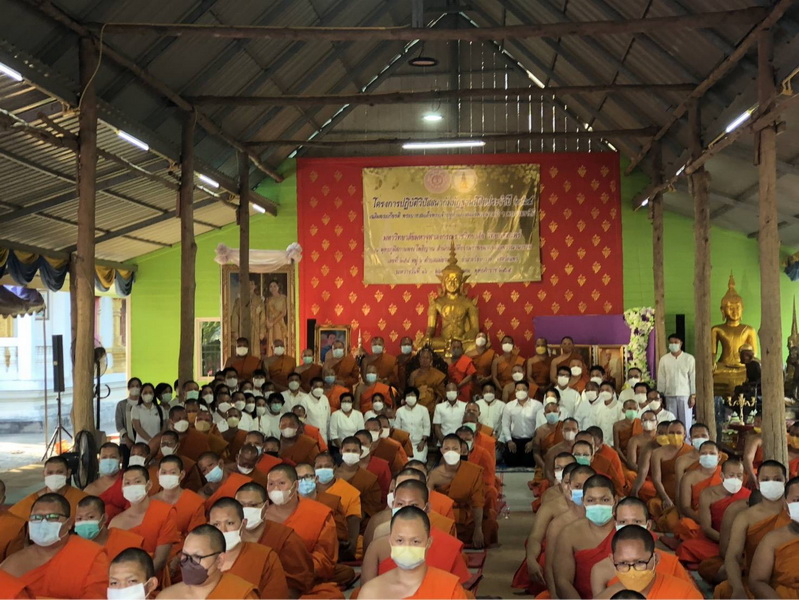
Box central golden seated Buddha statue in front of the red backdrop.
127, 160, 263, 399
417, 241, 480, 352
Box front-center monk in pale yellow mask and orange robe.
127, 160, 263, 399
358, 506, 466, 600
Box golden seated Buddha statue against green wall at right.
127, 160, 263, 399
710, 273, 757, 397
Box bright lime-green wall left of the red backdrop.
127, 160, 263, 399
130, 161, 297, 383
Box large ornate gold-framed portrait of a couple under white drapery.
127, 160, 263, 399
222, 265, 297, 359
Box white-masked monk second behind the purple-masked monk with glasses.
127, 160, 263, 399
236, 482, 314, 597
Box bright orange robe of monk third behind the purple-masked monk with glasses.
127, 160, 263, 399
283, 498, 338, 580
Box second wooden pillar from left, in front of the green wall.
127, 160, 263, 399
175, 111, 197, 384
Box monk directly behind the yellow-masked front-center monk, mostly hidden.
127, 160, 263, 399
361, 479, 471, 583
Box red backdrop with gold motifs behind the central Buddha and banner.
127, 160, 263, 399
297, 153, 624, 356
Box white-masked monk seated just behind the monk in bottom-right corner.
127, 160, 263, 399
713, 460, 791, 598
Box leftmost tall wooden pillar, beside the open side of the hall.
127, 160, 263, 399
70, 37, 97, 432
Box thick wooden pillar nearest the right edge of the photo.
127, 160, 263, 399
755, 30, 788, 465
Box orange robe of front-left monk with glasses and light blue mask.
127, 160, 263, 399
19, 535, 109, 598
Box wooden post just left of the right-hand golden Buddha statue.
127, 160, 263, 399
688, 101, 716, 440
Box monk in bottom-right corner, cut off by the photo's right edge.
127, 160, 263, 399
749, 477, 799, 598
